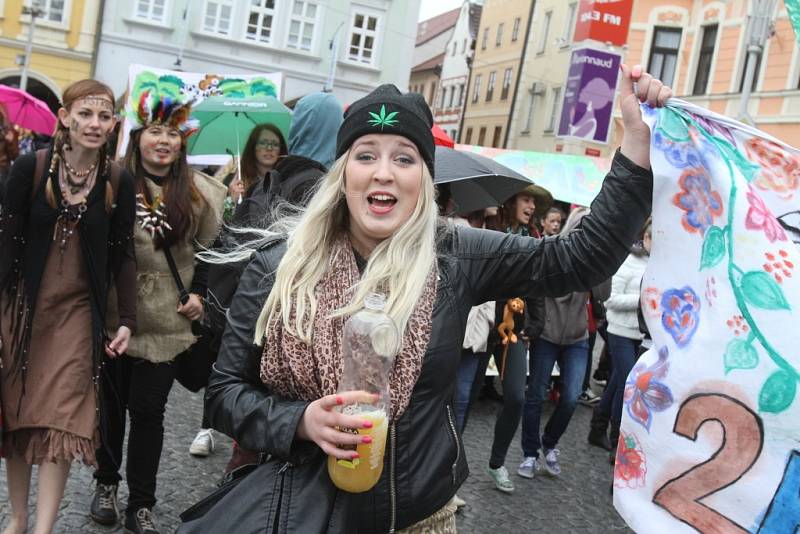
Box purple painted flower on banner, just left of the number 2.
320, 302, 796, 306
623, 347, 673, 432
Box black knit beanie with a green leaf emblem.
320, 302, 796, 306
336, 83, 436, 176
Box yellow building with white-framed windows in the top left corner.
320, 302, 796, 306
0, 0, 102, 111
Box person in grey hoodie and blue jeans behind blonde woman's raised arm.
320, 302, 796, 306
517, 208, 608, 478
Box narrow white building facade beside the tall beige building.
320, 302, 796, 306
433, 0, 482, 140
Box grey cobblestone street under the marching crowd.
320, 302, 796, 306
0, 385, 626, 534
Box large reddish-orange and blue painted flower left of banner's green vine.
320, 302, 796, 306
672, 168, 722, 235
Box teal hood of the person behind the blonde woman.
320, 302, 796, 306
289, 92, 344, 169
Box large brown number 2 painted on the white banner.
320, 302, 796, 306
653, 393, 764, 534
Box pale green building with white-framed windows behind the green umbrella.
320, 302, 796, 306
97, 0, 420, 104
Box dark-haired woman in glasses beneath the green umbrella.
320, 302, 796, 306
221, 124, 289, 211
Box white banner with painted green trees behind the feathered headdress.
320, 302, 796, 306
117, 65, 283, 164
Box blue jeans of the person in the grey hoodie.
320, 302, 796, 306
522, 338, 589, 456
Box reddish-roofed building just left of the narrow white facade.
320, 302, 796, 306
408, 9, 461, 109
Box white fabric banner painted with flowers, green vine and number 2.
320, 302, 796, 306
614, 100, 800, 534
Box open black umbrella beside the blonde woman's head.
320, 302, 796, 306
434, 146, 553, 213
